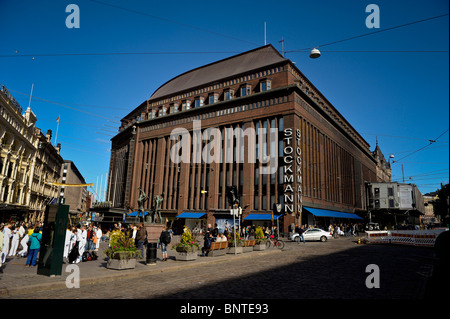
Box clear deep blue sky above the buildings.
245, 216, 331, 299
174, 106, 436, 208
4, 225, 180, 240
0, 0, 449, 200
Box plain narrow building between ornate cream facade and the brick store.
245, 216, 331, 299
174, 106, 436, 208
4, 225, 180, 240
59, 160, 88, 218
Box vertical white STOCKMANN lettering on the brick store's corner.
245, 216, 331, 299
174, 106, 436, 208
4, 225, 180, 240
283, 128, 303, 219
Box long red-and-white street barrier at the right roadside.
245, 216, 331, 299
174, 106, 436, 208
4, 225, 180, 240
366, 229, 446, 247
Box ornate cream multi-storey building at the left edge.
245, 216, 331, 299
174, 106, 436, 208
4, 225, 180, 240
0, 86, 62, 222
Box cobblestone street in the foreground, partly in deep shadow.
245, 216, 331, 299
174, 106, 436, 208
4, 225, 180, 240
2, 238, 434, 299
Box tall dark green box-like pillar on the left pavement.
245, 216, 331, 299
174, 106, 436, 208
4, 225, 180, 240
37, 204, 69, 277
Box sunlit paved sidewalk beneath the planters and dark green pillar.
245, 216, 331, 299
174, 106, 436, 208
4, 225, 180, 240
0, 243, 281, 298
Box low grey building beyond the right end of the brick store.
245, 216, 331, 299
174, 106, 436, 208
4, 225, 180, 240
367, 182, 425, 228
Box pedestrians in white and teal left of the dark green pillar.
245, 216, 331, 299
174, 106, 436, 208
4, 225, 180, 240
0, 222, 42, 270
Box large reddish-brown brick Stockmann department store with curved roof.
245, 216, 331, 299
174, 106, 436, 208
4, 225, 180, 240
104, 45, 384, 231
